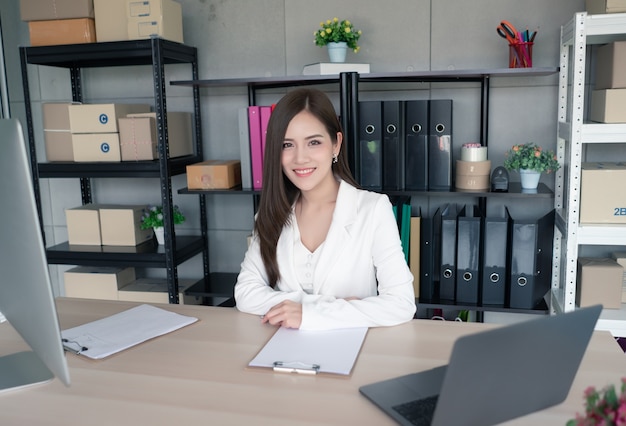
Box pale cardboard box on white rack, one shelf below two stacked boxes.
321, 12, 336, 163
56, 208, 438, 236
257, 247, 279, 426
580, 163, 626, 224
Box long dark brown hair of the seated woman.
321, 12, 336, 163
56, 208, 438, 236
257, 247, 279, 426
254, 88, 358, 288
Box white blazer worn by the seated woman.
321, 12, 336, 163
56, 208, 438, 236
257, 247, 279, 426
235, 181, 416, 330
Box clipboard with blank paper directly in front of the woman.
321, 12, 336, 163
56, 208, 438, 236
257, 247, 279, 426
248, 327, 368, 376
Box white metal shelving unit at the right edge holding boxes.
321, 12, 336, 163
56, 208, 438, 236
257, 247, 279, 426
550, 12, 626, 337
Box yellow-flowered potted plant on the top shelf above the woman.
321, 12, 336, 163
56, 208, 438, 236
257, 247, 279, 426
313, 18, 362, 62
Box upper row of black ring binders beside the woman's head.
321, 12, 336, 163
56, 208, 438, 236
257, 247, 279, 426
354, 99, 452, 191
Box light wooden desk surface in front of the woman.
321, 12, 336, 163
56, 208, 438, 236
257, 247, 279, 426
0, 299, 626, 426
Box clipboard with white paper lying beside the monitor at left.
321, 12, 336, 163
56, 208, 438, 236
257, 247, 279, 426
61, 305, 198, 359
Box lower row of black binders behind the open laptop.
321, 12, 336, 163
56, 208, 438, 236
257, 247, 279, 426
410, 204, 554, 309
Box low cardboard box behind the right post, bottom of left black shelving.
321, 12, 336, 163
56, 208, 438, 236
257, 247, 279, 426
117, 278, 202, 305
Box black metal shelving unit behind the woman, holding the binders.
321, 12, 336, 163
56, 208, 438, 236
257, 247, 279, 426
170, 67, 559, 315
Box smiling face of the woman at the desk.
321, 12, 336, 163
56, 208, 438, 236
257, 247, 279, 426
281, 110, 342, 196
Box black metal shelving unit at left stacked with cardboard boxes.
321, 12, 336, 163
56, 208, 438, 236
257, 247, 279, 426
20, 37, 209, 303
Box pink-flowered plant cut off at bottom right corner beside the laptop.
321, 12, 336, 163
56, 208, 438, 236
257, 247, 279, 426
567, 377, 626, 426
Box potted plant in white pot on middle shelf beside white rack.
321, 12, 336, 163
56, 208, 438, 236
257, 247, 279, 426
504, 142, 561, 189
